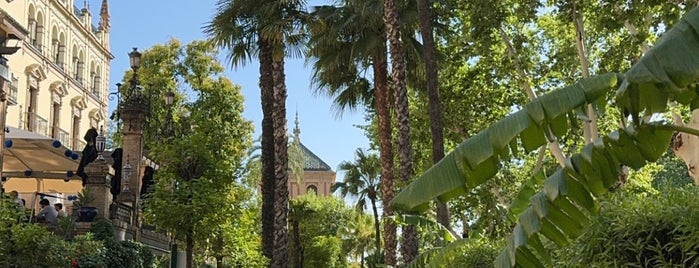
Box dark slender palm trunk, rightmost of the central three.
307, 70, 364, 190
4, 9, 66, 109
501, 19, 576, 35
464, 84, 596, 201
417, 0, 451, 230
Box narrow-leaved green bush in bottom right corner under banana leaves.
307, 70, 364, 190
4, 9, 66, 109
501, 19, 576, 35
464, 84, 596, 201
555, 186, 699, 267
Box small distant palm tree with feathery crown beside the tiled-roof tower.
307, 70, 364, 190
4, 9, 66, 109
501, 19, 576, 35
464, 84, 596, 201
331, 148, 381, 253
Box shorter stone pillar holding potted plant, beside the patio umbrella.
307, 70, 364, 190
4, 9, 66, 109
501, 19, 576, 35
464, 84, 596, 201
85, 161, 114, 220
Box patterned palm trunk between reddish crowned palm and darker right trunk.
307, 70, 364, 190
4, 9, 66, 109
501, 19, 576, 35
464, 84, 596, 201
384, 0, 418, 264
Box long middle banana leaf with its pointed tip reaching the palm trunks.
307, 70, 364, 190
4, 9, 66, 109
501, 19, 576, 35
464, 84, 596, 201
391, 74, 617, 212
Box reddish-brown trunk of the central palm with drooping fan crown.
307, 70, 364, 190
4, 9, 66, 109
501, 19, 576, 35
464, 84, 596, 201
373, 48, 397, 266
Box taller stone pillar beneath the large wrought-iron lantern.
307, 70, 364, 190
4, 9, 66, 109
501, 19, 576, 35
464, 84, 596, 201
118, 98, 147, 205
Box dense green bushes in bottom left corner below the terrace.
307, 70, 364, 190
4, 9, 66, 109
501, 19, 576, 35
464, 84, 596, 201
0, 201, 155, 268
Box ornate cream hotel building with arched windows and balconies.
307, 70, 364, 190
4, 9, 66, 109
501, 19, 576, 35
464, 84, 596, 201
0, 0, 114, 151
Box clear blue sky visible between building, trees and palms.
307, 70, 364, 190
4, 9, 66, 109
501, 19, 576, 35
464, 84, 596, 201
102, 0, 369, 176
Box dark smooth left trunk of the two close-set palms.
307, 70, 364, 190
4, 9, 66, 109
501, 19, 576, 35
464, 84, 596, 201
258, 40, 275, 260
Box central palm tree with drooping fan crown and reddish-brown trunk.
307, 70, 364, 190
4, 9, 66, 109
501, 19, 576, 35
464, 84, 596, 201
308, 0, 397, 265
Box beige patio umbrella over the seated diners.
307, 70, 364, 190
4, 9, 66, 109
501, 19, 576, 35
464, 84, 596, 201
2, 127, 80, 179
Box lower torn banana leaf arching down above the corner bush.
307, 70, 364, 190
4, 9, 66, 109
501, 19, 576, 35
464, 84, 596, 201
495, 124, 673, 267
